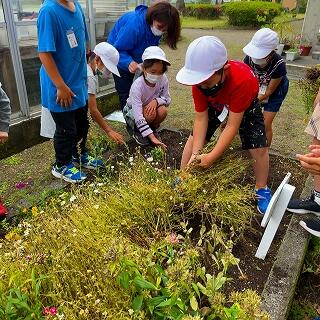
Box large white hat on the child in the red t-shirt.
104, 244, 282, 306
176, 36, 228, 85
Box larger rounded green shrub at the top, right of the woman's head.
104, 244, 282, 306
223, 1, 282, 27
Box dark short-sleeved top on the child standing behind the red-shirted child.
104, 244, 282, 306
243, 52, 287, 95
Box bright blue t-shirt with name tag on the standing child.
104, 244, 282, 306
37, 0, 88, 112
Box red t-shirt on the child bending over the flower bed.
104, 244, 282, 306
192, 60, 259, 113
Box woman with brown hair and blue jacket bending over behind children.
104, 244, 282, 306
107, 1, 181, 110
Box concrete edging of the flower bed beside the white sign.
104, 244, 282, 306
262, 175, 313, 320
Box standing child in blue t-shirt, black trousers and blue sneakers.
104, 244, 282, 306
37, 0, 89, 182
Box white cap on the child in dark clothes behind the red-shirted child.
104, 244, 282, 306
242, 28, 279, 59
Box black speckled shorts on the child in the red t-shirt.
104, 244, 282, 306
191, 100, 268, 150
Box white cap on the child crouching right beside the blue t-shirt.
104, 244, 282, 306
93, 42, 120, 77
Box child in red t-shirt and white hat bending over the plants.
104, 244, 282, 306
177, 36, 272, 214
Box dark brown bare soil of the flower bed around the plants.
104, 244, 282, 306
111, 129, 307, 293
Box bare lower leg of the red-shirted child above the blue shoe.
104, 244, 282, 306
249, 147, 269, 188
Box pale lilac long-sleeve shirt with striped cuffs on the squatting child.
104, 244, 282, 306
127, 74, 171, 137
